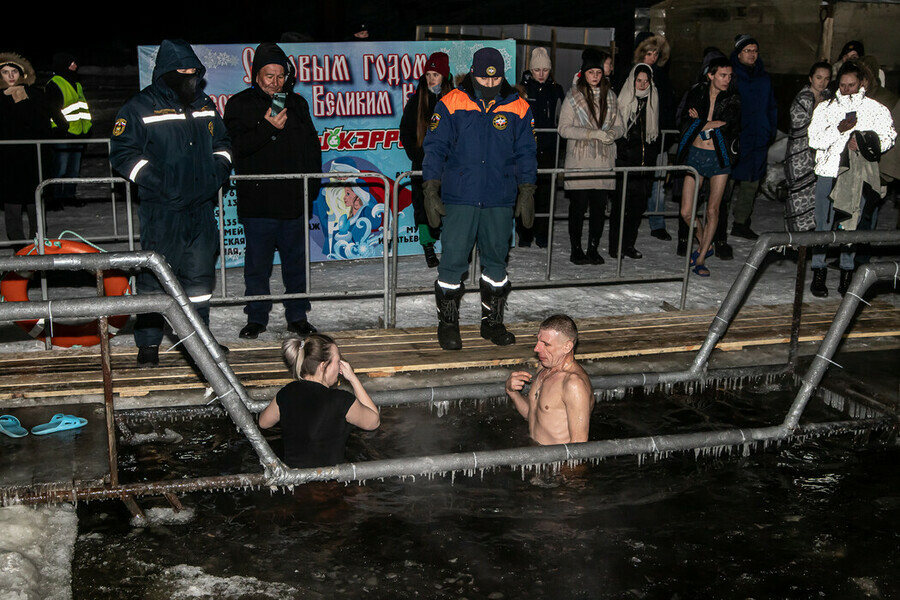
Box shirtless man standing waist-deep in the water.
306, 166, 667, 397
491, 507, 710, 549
506, 315, 594, 445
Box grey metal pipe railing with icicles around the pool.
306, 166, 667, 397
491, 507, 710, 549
0, 231, 900, 504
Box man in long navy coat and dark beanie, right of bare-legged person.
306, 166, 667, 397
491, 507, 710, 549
723, 35, 778, 240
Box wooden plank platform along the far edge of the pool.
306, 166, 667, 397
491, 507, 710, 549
0, 301, 900, 403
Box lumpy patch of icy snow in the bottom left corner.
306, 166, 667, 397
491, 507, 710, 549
0, 504, 78, 600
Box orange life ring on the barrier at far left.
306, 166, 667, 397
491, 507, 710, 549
0, 240, 131, 348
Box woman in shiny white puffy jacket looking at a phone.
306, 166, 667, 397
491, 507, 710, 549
808, 62, 897, 297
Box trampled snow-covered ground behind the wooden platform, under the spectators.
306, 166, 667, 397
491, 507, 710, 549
0, 185, 898, 351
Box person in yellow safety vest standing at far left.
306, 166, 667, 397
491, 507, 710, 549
44, 52, 91, 210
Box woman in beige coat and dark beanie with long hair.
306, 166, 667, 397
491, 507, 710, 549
559, 52, 625, 265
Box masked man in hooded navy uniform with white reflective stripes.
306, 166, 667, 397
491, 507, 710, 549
109, 40, 231, 367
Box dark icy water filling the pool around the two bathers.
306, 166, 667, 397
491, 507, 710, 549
73, 383, 900, 599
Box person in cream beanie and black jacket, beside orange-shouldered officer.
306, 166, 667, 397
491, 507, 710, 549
516, 46, 566, 248
